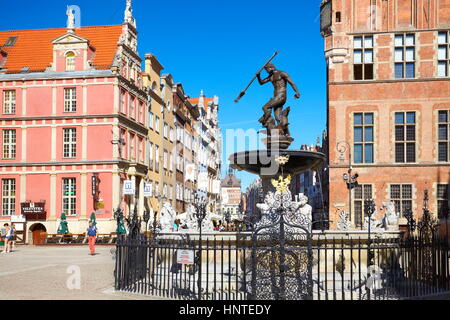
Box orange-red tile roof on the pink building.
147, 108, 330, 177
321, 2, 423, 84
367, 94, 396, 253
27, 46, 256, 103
0, 25, 122, 73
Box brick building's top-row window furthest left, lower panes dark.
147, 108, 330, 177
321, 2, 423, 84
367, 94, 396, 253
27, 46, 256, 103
353, 36, 373, 80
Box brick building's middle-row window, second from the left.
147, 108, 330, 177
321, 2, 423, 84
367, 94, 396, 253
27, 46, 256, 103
395, 112, 416, 163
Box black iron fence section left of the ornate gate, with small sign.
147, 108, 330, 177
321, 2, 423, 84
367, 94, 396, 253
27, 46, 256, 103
115, 235, 250, 300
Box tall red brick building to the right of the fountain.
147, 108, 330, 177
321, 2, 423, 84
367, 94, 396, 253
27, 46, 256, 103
321, 0, 450, 227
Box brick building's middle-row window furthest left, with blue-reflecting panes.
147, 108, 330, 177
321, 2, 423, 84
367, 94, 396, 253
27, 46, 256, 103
353, 113, 374, 163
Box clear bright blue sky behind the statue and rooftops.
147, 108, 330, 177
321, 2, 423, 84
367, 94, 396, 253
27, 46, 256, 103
0, 0, 326, 188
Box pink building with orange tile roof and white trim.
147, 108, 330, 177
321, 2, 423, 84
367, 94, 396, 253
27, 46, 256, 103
0, 6, 148, 243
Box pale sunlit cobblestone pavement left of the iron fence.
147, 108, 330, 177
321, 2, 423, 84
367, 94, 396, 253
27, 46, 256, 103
0, 246, 158, 300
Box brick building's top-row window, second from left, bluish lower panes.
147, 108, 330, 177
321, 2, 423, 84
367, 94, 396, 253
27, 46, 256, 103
394, 34, 416, 79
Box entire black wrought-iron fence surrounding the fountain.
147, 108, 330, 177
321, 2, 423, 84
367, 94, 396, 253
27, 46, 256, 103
115, 233, 450, 300
